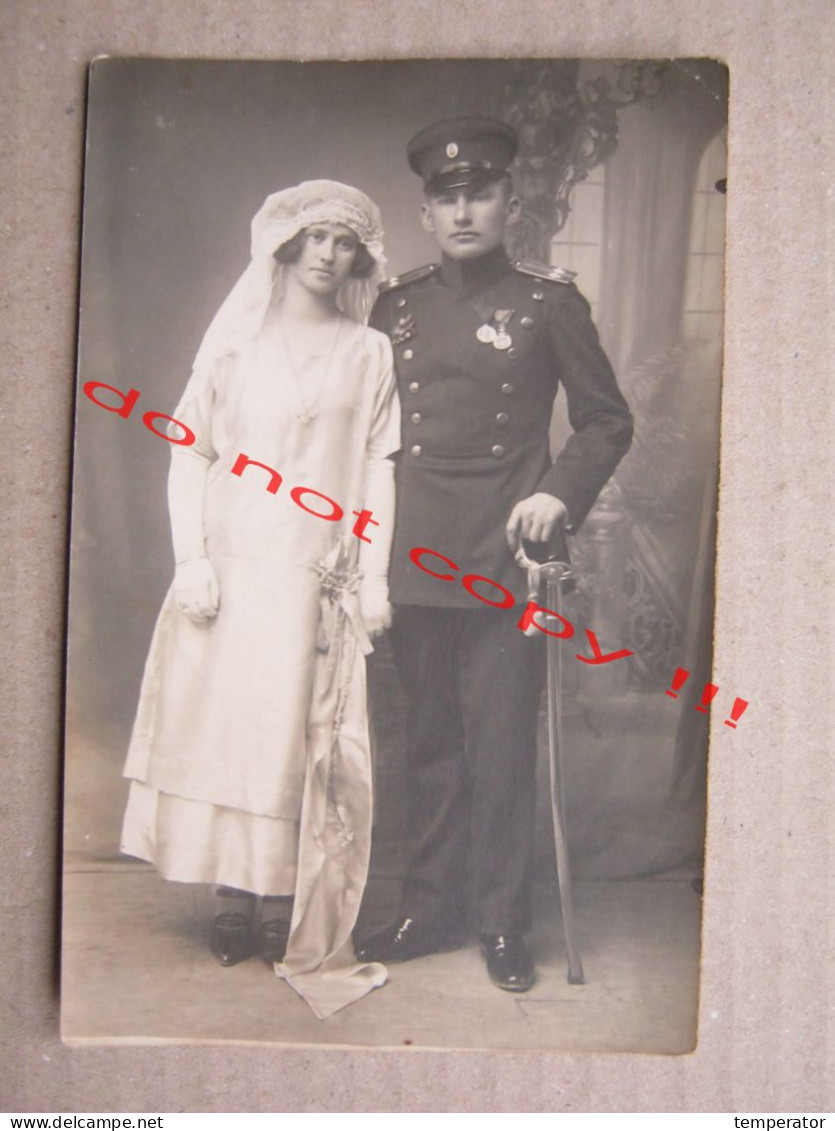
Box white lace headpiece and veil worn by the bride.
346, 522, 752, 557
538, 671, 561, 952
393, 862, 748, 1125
195, 181, 386, 369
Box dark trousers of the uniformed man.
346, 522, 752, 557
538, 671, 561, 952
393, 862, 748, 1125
393, 605, 545, 934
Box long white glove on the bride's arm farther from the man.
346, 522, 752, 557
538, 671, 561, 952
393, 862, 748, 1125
169, 448, 221, 621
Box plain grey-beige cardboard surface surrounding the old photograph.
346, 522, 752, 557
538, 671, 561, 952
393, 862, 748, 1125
0, 0, 835, 1113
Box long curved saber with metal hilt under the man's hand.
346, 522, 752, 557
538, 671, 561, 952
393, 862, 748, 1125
516, 545, 586, 985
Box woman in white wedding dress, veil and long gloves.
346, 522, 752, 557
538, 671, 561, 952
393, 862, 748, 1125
121, 181, 399, 1018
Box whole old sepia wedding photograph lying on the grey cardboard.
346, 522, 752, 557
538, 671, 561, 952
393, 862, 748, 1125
61, 58, 724, 1053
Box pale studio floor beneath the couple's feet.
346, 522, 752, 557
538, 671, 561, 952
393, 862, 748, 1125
62, 863, 699, 1053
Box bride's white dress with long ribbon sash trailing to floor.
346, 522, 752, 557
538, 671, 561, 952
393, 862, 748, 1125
121, 320, 399, 1016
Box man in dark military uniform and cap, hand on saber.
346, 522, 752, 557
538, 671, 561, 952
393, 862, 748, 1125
358, 119, 631, 991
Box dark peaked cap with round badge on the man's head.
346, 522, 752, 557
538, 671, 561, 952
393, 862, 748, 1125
406, 118, 519, 191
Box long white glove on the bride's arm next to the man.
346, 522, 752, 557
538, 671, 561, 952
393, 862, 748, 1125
359, 459, 395, 639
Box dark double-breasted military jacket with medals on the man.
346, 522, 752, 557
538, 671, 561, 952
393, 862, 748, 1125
371, 249, 631, 607
